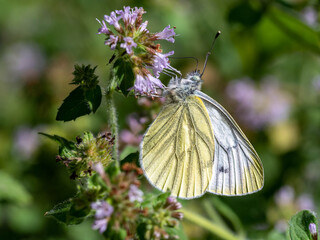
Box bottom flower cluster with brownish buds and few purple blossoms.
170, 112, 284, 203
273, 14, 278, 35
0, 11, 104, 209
91, 163, 183, 239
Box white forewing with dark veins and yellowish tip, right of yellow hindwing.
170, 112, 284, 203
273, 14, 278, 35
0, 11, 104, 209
195, 91, 264, 196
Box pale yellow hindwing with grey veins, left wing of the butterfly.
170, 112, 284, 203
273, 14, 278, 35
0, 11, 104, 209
140, 96, 214, 199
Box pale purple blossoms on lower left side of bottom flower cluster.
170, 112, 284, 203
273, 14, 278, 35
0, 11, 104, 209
91, 201, 113, 233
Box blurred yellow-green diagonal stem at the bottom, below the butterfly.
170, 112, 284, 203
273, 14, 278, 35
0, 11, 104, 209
180, 209, 243, 240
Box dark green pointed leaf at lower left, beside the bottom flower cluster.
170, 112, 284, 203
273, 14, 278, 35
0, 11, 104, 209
44, 200, 83, 225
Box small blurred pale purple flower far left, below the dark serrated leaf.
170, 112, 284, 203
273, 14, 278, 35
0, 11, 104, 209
13, 126, 39, 159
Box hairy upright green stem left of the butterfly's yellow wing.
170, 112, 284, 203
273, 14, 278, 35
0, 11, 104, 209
106, 92, 119, 162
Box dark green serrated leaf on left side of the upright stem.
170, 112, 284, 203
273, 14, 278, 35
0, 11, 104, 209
56, 85, 102, 122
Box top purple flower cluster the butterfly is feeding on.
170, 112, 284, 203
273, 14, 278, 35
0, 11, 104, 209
97, 7, 178, 95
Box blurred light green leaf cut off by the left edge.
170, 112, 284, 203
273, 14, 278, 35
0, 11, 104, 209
0, 170, 31, 205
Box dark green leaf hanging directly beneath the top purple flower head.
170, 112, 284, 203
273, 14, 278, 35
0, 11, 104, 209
113, 58, 134, 96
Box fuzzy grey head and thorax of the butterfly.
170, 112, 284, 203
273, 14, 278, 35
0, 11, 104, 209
164, 71, 202, 102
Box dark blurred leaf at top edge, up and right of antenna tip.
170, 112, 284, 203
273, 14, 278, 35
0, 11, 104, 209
228, 1, 262, 27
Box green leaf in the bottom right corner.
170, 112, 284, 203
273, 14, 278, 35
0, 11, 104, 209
288, 210, 318, 240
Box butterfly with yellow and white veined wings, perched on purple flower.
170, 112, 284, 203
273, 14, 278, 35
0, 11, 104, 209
140, 32, 264, 199
